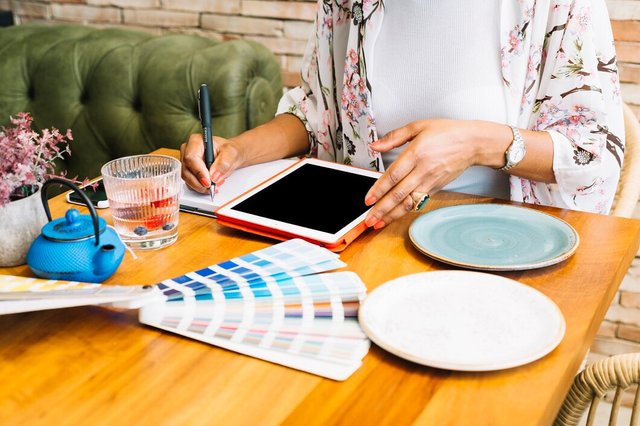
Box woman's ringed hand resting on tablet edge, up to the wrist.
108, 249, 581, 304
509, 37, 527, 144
365, 119, 475, 229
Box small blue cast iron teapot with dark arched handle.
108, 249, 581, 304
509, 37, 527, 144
27, 178, 125, 283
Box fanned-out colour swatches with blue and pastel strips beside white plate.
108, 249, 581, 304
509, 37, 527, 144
140, 239, 369, 380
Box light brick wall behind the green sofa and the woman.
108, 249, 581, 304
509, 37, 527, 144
0, 0, 640, 358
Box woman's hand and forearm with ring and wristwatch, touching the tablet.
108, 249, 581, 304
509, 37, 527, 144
365, 120, 556, 229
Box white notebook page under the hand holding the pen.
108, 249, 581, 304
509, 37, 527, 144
180, 159, 297, 217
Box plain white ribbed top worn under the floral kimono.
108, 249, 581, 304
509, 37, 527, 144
369, 0, 509, 199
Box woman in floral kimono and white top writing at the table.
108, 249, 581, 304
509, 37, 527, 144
181, 0, 624, 229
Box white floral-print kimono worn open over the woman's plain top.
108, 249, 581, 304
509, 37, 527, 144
278, 0, 624, 214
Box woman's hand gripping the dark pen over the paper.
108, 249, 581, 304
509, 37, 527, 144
180, 133, 244, 194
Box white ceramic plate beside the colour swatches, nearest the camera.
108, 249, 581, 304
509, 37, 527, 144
359, 271, 565, 371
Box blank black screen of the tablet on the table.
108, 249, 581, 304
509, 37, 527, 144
231, 163, 377, 234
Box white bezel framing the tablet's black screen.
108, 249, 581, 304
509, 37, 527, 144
216, 158, 382, 244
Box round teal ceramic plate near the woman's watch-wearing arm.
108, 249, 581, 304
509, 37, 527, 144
409, 204, 580, 271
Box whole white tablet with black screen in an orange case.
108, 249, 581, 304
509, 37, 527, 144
216, 158, 381, 250
